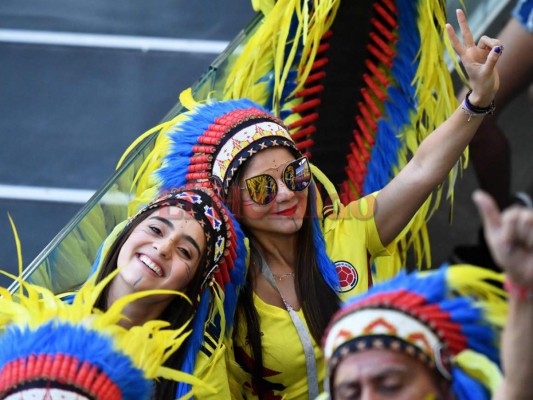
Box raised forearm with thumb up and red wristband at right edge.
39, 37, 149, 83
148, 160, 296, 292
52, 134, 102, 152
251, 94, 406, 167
474, 191, 533, 400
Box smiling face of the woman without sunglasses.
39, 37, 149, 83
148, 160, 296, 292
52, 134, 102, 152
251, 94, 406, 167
100, 201, 207, 326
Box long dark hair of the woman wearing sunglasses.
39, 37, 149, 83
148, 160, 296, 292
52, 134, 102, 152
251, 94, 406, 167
226, 163, 340, 398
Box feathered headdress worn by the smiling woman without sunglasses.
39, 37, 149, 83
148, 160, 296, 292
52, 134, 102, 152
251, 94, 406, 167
93, 185, 246, 396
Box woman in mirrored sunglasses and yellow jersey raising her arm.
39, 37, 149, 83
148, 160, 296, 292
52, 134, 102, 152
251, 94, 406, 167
135, 12, 502, 399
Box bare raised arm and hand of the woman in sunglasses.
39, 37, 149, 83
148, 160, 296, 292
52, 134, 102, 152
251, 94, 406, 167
375, 10, 503, 245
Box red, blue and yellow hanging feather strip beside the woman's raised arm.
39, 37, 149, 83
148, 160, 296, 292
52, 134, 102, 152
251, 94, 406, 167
340, 0, 456, 266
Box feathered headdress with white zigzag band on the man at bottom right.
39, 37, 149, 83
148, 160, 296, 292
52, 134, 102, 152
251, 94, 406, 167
323, 265, 507, 400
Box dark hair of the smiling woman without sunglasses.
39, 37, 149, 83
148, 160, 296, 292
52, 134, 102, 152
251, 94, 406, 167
95, 209, 207, 400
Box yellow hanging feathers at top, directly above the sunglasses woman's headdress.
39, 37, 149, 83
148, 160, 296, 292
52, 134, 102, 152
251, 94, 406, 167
224, 0, 340, 116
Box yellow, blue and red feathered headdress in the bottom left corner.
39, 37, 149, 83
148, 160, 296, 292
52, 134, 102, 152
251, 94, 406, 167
0, 276, 202, 400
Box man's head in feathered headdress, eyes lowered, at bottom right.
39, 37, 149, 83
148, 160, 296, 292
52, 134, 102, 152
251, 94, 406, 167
323, 267, 504, 400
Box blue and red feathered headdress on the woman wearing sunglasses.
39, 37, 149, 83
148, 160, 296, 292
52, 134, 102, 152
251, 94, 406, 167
157, 99, 301, 198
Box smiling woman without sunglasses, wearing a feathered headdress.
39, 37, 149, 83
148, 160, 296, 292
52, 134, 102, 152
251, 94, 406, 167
89, 187, 246, 399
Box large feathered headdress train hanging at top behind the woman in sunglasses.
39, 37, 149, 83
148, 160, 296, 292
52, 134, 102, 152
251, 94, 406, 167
116, 0, 466, 280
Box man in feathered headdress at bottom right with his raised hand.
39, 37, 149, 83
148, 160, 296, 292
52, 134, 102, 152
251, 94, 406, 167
321, 192, 533, 400
